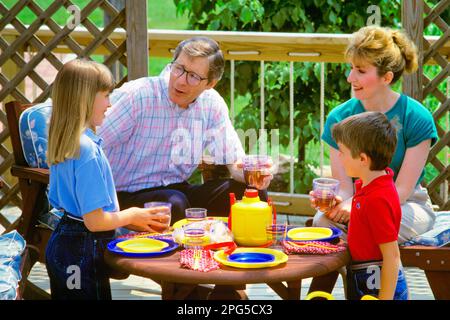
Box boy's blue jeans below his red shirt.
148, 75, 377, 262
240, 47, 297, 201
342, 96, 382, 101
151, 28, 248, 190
347, 261, 408, 300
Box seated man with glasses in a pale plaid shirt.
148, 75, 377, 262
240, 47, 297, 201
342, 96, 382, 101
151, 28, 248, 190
97, 37, 271, 222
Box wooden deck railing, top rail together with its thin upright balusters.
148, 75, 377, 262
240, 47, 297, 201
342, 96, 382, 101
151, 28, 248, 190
2, 26, 450, 215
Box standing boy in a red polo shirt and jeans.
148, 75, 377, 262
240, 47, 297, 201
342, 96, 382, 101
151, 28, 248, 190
332, 112, 408, 300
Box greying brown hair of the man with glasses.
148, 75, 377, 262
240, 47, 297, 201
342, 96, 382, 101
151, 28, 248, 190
173, 37, 225, 82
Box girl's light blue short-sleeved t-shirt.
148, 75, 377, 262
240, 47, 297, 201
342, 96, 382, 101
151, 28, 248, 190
48, 129, 119, 218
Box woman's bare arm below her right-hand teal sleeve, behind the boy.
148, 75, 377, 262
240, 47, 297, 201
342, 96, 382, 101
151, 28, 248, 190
395, 139, 431, 204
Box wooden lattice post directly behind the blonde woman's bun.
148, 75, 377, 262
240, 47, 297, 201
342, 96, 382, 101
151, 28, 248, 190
402, 0, 424, 101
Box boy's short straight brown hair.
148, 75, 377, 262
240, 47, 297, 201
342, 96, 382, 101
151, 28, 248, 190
331, 111, 397, 171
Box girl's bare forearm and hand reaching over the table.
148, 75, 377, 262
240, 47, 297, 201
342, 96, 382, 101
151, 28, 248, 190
83, 207, 169, 232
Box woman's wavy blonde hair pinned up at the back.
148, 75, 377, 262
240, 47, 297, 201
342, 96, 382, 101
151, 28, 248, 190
345, 26, 418, 84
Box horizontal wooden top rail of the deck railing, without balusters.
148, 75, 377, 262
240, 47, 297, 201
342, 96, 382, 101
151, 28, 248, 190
1, 25, 450, 64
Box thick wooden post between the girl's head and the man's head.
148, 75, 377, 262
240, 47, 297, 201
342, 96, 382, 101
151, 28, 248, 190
126, 0, 149, 81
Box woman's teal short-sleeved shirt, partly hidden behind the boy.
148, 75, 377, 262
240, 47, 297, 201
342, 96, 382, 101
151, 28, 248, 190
322, 94, 438, 184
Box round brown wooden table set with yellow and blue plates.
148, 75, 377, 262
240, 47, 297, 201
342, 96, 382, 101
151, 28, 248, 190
105, 245, 350, 300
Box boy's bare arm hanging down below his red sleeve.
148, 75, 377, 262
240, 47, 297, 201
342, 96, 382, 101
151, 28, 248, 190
378, 241, 400, 300
